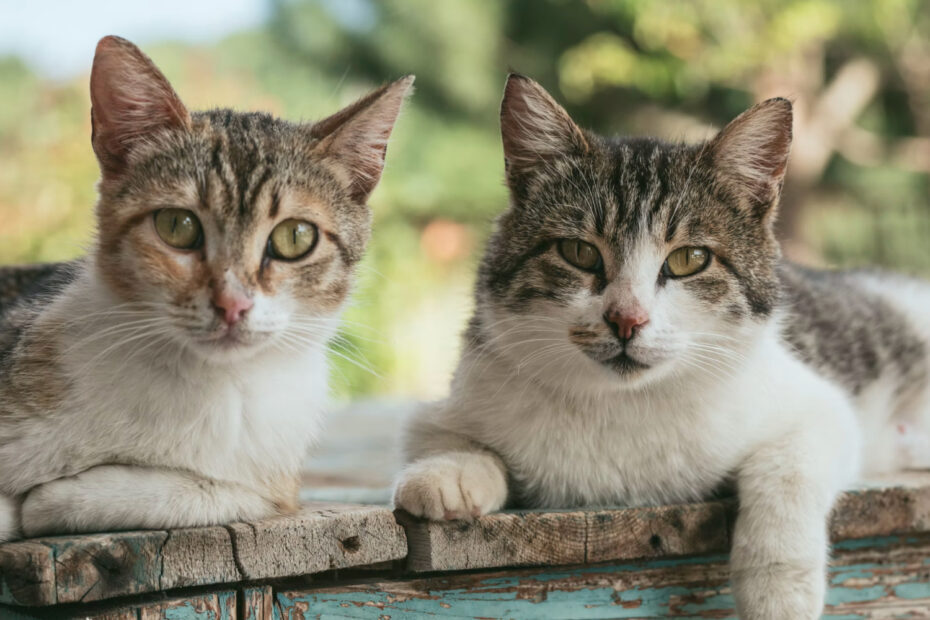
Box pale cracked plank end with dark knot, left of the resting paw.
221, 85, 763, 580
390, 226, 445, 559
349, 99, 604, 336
227, 504, 407, 580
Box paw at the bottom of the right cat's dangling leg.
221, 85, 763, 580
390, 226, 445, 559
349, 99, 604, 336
732, 564, 826, 620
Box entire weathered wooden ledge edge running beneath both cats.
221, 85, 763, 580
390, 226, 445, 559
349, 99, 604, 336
0, 472, 930, 611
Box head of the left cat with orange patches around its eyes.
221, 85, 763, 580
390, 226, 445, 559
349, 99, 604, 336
90, 37, 413, 360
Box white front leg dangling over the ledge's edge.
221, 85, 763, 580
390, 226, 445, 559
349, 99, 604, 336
730, 422, 856, 620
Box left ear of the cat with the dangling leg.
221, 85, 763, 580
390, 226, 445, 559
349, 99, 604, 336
501, 73, 588, 177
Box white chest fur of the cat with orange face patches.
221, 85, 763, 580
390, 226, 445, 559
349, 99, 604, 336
65, 350, 326, 482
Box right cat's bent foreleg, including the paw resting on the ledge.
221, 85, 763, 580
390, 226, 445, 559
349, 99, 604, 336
394, 414, 507, 521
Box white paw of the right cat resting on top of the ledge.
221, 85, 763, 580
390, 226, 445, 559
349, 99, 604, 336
394, 452, 507, 521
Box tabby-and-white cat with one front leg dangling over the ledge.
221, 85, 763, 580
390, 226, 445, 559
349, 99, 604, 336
394, 75, 930, 620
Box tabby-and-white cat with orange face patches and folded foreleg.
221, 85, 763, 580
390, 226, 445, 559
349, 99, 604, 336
0, 36, 413, 541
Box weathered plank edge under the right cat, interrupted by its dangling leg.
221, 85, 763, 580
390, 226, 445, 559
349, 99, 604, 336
398, 472, 930, 571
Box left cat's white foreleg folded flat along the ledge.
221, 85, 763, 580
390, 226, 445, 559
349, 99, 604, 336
22, 465, 276, 536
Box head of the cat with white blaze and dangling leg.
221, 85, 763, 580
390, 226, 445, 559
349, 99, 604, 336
472, 75, 792, 388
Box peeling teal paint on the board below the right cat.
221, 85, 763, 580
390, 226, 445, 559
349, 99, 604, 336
275, 536, 930, 620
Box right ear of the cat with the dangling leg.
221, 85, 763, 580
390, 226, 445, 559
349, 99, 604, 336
709, 98, 792, 214
